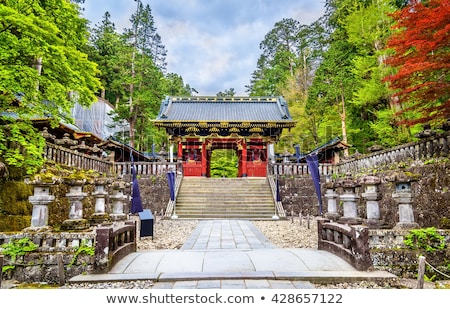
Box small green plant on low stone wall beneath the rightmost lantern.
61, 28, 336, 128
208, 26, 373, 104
403, 227, 445, 252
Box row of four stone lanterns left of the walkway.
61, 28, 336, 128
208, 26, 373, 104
28, 177, 129, 230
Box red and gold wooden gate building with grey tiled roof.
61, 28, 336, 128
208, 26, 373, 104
154, 97, 295, 177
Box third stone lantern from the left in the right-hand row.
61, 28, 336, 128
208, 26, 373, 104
360, 175, 382, 228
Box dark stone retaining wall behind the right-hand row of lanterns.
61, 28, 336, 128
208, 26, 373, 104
279, 160, 450, 229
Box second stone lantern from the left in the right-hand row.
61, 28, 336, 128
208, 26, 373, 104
338, 173, 363, 225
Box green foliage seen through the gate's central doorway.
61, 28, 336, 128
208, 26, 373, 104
211, 149, 238, 178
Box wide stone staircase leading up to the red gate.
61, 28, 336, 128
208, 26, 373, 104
176, 177, 275, 220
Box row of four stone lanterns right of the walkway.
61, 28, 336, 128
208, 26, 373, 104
324, 174, 418, 229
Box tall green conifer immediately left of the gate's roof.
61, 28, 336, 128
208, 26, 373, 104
103, 1, 168, 151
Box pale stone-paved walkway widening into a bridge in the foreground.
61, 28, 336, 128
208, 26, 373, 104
70, 220, 395, 288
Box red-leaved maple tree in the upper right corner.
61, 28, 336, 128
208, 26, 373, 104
384, 0, 450, 125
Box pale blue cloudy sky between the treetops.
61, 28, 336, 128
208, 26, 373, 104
83, 0, 324, 95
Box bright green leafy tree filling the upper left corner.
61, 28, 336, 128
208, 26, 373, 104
0, 0, 100, 174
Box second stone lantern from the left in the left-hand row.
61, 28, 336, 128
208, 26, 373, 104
61, 180, 89, 230
